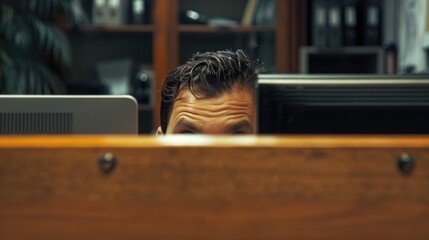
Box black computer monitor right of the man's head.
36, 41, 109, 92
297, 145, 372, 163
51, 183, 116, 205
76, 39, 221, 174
257, 74, 429, 134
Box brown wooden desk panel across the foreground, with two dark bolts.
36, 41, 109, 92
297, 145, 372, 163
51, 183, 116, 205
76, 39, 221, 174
0, 136, 429, 239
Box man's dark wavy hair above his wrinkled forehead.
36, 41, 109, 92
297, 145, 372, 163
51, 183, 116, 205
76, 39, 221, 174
161, 50, 261, 133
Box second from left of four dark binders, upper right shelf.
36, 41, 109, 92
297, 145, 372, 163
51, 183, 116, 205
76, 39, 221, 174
328, 0, 343, 47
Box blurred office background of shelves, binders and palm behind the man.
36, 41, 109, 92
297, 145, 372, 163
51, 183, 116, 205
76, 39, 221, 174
0, 0, 429, 133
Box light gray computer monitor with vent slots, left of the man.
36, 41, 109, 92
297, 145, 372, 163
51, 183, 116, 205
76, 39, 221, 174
0, 95, 138, 135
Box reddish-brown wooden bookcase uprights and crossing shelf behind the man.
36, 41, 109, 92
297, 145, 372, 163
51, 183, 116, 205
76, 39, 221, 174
153, 0, 308, 126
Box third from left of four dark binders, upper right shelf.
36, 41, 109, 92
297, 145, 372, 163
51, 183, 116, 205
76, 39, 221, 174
343, 0, 360, 46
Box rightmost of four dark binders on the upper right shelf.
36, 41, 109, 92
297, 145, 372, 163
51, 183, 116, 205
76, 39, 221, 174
363, 0, 382, 46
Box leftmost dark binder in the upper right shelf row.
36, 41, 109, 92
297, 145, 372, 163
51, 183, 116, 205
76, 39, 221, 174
311, 0, 328, 47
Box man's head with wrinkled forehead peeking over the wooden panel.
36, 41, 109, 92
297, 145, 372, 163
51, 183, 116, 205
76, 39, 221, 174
157, 50, 259, 135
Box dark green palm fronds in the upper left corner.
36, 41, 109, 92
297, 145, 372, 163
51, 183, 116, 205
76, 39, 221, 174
0, 0, 87, 94
